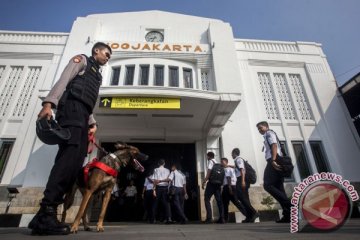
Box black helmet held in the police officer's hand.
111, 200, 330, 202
36, 118, 71, 145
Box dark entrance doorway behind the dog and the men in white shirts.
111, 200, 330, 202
97, 142, 199, 222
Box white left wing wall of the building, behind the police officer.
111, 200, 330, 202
0, 31, 68, 185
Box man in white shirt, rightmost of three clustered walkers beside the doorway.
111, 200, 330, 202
231, 148, 259, 223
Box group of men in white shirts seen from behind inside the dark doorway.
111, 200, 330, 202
143, 159, 188, 224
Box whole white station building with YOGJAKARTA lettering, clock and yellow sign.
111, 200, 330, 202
0, 11, 360, 223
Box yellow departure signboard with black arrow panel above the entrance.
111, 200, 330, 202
99, 97, 180, 109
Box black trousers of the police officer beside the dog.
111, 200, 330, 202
40, 99, 90, 207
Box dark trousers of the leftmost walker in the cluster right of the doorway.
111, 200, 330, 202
204, 182, 224, 220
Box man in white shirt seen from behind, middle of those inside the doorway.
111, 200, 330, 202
152, 159, 172, 224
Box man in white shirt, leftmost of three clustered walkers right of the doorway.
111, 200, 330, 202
202, 152, 225, 223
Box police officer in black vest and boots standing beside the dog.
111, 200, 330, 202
28, 42, 112, 235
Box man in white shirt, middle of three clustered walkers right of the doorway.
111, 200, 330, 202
221, 158, 247, 222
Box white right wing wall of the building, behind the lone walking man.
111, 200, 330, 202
222, 39, 360, 182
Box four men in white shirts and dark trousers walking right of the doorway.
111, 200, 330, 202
202, 121, 291, 223
